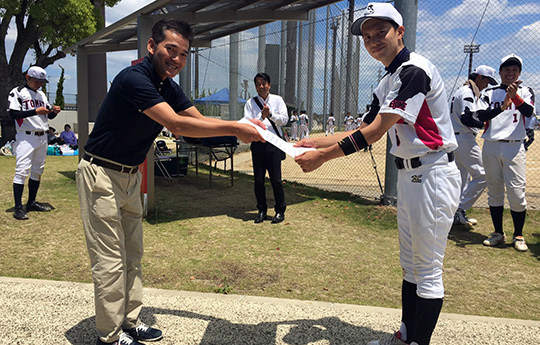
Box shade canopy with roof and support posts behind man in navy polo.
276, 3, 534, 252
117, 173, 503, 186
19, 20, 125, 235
64, 0, 340, 213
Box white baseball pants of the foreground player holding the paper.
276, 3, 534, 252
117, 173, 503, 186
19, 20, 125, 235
397, 153, 461, 299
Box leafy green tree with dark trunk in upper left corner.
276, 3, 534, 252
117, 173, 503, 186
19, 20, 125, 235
0, 0, 120, 146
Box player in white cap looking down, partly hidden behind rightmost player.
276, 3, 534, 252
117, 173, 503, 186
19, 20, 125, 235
450, 65, 497, 225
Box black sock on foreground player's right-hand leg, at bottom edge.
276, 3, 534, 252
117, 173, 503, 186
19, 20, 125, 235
414, 297, 443, 345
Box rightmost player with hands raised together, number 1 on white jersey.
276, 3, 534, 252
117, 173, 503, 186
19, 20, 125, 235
462, 54, 535, 252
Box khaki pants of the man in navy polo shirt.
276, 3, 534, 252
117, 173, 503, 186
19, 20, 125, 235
76, 160, 143, 342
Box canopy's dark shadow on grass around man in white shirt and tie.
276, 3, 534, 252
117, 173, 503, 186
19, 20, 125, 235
147, 168, 373, 224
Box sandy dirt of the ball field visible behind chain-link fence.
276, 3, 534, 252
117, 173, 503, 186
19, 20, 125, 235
172, 133, 540, 209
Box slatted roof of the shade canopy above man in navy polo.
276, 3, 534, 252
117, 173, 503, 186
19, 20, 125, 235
64, 0, 340, 54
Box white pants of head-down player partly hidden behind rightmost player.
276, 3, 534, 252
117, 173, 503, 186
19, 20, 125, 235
454, 132, 486, 210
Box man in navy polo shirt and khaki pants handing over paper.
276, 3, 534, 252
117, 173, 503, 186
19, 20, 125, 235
76, 19, 265, 345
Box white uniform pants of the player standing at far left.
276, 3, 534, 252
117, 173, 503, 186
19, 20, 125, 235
13, 131, 47, 184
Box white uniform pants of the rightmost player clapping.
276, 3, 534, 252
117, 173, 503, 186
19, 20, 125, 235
482, 140, 527, 212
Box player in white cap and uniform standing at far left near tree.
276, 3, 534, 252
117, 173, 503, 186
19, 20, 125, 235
8, 66, 60, 220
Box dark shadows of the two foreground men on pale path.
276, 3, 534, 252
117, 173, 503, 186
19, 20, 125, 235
65, 307, 386, 345
